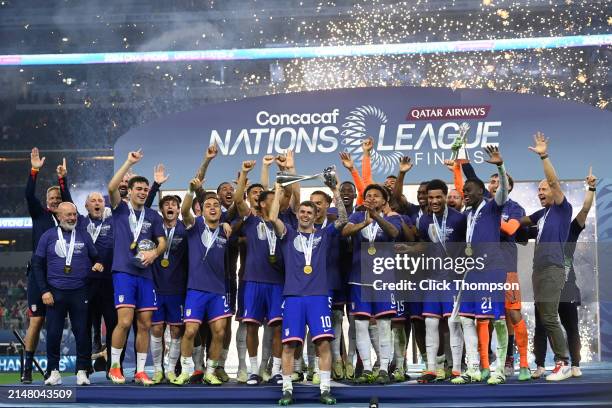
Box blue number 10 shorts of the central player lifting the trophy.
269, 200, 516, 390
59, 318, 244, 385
282, 296, 335, 343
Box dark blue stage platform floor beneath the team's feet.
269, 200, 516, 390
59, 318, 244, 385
1, 364, 612, 407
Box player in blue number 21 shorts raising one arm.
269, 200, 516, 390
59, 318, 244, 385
456, 146, 509, 385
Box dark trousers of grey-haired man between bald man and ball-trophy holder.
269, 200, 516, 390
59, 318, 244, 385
87, 279, 117, 371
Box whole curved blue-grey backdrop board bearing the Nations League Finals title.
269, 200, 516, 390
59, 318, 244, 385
115, 87, 612, 189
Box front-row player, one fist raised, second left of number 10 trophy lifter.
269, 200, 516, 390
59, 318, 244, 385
172, 177, 232, 385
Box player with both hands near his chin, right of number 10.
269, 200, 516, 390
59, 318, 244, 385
342, 184, 401, 384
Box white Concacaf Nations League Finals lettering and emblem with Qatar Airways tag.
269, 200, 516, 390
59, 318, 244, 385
209, 104, 502, 174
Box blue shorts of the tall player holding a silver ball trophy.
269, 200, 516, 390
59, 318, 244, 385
113, 272, 157, 312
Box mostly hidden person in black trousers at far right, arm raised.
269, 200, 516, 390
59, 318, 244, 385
533, 169, 597, 378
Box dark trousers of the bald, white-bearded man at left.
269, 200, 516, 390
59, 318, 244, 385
47, 286, 91, 372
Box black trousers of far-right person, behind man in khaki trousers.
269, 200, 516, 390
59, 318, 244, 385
533, 302, 581, 367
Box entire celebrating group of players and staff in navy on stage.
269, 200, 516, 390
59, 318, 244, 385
22, 132, 596, 405
